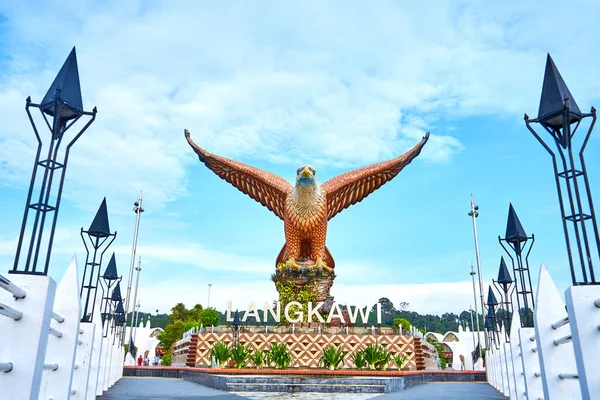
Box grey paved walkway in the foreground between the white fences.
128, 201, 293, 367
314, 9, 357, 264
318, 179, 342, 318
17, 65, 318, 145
99, 377, 506, 400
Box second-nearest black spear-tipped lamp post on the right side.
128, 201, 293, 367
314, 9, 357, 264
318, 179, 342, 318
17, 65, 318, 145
498, 204, 535, 328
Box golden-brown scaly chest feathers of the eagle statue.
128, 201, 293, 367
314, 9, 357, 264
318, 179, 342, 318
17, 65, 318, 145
286, 188, 327, 233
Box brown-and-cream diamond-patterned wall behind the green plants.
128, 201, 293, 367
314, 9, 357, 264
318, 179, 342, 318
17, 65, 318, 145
192, 333, 425, 370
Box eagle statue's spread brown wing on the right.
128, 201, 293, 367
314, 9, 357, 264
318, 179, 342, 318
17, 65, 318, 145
321, 132, 429, 220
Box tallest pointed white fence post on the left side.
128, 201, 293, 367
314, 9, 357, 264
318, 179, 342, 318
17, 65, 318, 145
40, 256, 81, 399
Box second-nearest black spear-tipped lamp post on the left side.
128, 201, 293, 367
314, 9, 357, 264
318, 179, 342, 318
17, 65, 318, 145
79, 197, 117, 322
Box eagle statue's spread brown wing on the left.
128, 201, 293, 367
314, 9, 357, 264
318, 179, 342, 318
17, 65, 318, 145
185, 129, 292, 219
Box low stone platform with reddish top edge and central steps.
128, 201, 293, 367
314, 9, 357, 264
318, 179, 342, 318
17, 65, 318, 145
123, 367, 486, 394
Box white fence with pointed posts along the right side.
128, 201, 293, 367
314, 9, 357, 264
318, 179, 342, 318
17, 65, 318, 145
486, 264, 600, 400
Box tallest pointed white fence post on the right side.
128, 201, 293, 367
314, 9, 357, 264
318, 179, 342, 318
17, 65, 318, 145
534, 264, 581, 400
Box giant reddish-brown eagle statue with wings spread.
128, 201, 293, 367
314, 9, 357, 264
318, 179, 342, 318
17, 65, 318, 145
185, 129, 429, 271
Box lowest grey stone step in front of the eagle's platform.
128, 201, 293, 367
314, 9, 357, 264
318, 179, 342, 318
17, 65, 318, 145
226, 382, 385, 393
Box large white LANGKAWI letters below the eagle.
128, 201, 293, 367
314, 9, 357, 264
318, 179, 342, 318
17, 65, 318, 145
226, 301, 381, 325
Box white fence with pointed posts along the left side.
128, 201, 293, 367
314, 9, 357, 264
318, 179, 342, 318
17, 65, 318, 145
0, 257, 124, 400
